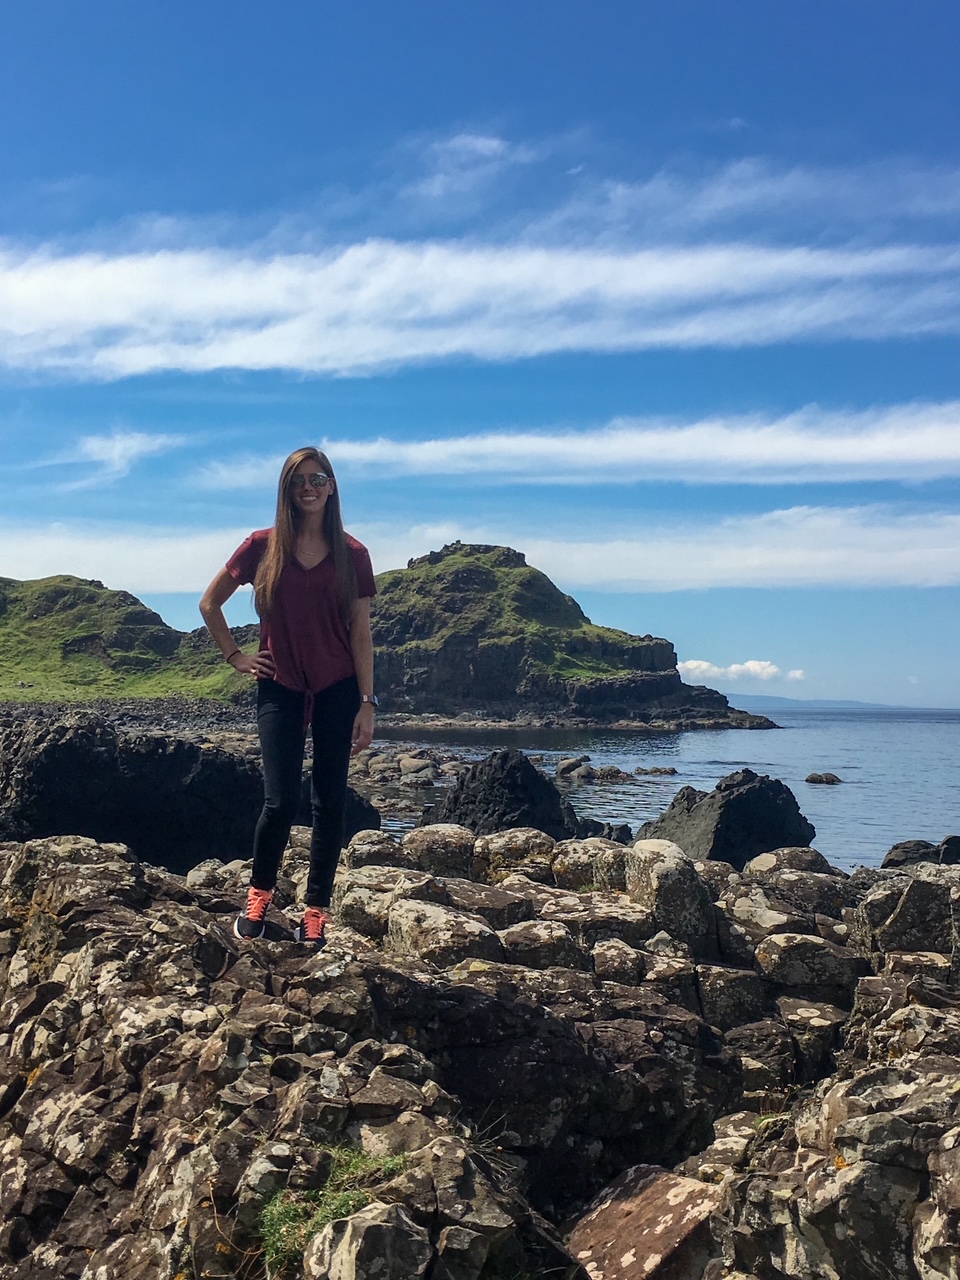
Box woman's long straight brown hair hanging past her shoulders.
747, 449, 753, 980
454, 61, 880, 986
253, 445, 357, 626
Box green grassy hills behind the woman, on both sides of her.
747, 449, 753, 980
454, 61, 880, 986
0, 543, 742, 721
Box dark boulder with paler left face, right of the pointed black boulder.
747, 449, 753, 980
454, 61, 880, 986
637, 769, 817, 870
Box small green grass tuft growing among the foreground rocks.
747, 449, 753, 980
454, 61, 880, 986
260, 1147, 407, 1275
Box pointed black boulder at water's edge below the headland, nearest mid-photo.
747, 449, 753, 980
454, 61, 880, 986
421, 749, 630, 844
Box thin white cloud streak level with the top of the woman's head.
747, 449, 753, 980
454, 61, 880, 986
197, 401, 960, 489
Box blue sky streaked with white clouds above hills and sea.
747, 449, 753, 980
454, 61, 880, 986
0, 0, 960, 707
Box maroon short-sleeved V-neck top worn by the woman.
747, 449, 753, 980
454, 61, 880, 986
227, 529, 376, 694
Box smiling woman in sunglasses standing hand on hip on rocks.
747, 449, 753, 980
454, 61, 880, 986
200, 448, 378, 948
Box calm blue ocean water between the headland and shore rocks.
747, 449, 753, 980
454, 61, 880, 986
378, 708, 960, 870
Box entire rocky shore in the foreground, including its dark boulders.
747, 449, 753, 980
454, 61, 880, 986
0, 717, 960, 1280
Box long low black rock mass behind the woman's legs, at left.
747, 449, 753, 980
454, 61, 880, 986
0, 714, 379, 873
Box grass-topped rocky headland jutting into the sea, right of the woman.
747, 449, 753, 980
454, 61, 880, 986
372, 543, 771, 728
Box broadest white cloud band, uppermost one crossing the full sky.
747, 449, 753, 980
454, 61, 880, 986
0, 239, 960, 379
